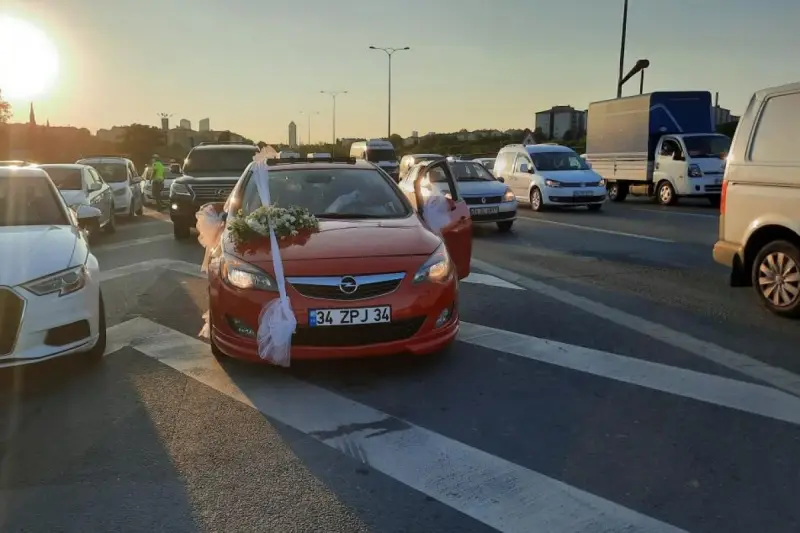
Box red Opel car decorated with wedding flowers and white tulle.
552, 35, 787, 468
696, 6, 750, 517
209, 156, 472, 361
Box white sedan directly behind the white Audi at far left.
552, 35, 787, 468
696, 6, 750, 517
37, 163, 117, 240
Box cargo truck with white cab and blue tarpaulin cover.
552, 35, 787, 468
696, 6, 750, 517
585, 91, 731, 205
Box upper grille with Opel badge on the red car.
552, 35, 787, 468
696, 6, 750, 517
287, 272, 406, 301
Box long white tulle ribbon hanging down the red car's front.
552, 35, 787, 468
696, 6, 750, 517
252, 160, 297, 366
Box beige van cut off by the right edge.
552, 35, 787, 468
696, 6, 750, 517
714, 83, 800, 317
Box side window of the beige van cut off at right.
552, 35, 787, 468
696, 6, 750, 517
750, 93, 800, 163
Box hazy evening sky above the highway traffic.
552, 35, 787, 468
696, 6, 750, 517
0, 0, 800, 143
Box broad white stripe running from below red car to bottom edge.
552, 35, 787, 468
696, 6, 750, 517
109, 318, 682, 533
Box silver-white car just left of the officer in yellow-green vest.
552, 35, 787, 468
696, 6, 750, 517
75, 155, 144, 218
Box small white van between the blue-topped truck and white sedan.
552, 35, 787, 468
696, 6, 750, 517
494, 144, 606, 211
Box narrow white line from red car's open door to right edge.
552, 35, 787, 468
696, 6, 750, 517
472, 257, 800, 396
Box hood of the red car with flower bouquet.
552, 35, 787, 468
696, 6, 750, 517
226, 216, 441, 264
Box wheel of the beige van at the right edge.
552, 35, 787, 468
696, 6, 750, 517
751, 237, 800, 318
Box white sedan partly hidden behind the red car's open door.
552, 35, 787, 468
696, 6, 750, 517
400, 158, 517, 232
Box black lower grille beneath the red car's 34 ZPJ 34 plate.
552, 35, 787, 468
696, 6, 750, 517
292, 317, 425, 347
